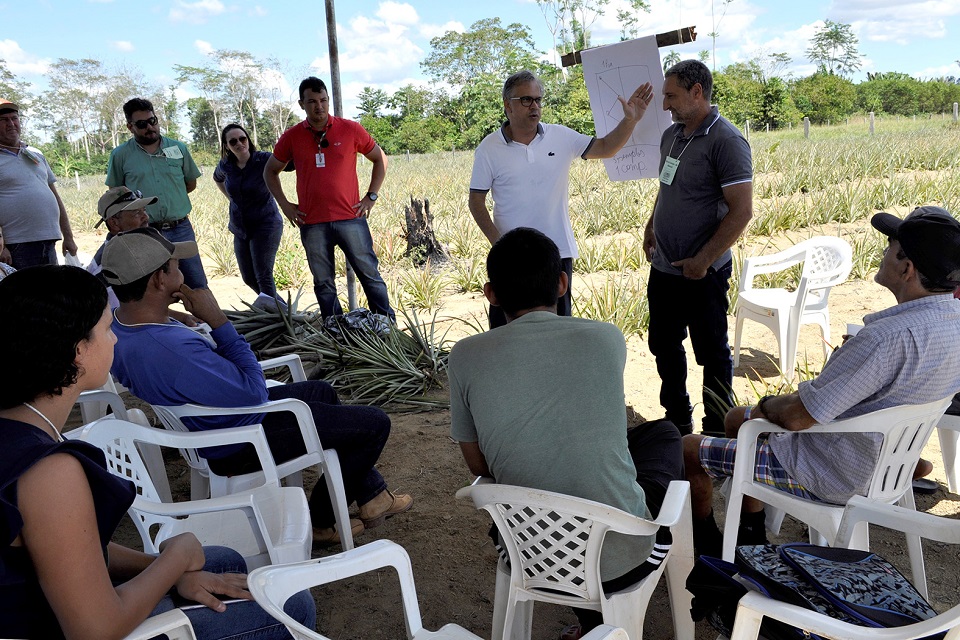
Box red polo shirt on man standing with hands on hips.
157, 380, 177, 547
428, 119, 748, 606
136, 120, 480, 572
273, 116, 377, 224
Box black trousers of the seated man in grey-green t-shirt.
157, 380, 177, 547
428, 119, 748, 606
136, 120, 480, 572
573, 420, 683, 633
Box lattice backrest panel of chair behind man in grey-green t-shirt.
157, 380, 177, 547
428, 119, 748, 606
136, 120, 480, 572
496, 503, 599, 598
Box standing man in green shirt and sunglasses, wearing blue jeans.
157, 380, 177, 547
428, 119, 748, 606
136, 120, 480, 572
106, 98, 207, 289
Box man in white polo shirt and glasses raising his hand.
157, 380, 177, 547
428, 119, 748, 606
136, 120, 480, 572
470, 70, 653, 329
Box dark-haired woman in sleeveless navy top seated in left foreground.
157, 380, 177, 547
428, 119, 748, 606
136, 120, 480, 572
0, 266, 316, 640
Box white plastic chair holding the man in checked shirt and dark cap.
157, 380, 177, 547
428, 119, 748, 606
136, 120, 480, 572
723, 398, 950, 575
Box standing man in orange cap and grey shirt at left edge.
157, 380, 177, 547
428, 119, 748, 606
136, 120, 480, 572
0, 99, 77, 269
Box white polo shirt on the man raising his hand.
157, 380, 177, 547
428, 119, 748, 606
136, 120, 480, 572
470, 124, 594, 258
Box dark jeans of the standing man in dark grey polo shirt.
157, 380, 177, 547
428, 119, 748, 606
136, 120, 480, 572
647, 264, 733, 435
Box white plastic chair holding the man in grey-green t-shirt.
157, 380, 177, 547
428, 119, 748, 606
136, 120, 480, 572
457, 481, 694, 640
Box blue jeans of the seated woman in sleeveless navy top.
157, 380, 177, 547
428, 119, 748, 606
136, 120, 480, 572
150, 547, 317, 640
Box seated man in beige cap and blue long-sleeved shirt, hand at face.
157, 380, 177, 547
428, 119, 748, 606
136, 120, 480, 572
101, 227, 413, 544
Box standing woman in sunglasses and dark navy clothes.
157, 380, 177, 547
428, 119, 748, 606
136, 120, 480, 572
213, 123, 283, 297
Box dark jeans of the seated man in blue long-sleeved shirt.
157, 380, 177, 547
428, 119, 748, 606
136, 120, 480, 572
208, 380, 390, 528
